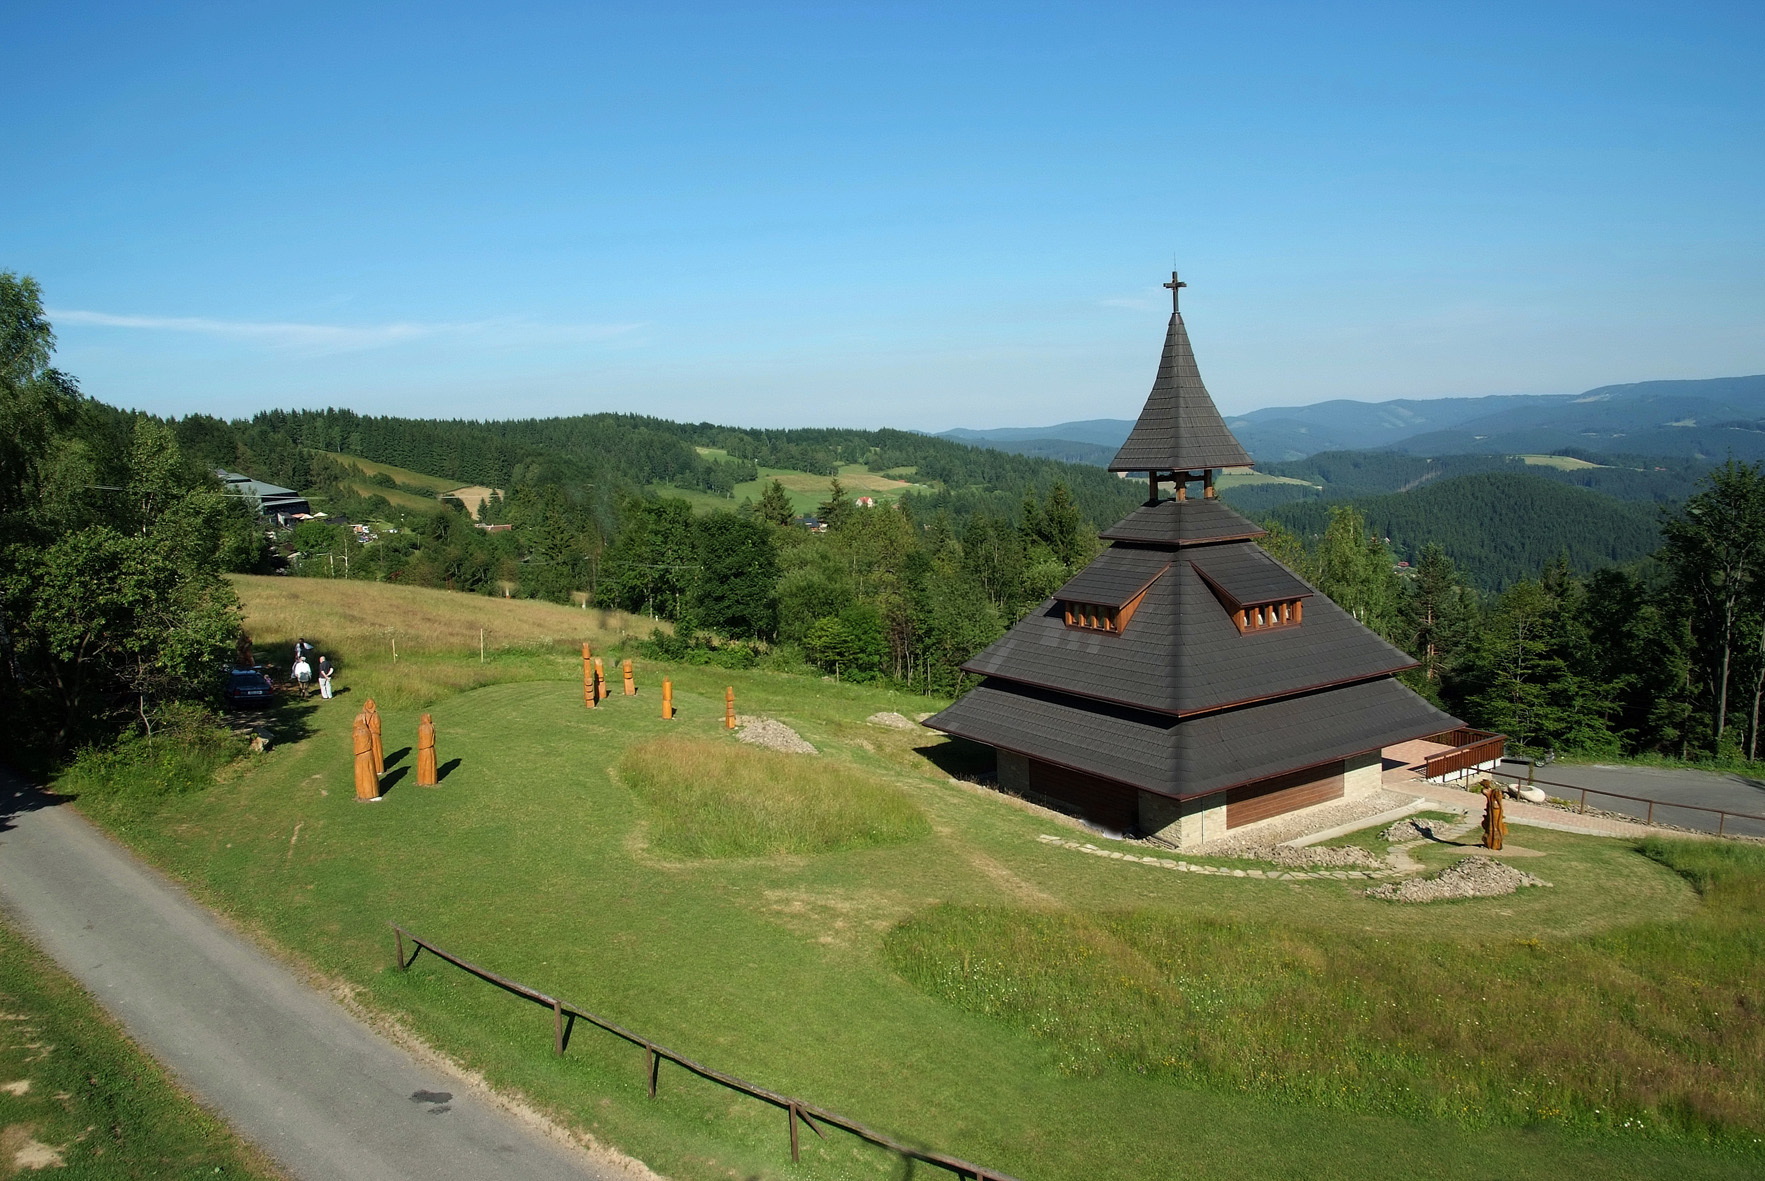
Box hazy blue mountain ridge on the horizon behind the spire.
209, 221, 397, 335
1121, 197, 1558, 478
939, 374, 1765, 466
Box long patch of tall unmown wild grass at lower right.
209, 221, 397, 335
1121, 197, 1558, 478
884, 842, 1765, 1149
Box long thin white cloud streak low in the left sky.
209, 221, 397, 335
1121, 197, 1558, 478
48, 307, 644, 351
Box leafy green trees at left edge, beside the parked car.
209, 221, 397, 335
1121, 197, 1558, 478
0, 272, 265, 766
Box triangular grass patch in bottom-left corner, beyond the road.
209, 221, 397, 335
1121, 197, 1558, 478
0, 920, 282, 1181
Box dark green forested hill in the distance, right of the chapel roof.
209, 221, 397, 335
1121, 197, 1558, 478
1267, 471, 1661, 590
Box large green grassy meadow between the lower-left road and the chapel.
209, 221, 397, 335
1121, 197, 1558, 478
65, 581, 1765, 1181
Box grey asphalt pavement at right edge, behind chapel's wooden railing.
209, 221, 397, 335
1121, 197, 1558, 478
1500, 763, 1765, 837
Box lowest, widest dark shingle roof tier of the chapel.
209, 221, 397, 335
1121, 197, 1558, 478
927, 678, 1458, 798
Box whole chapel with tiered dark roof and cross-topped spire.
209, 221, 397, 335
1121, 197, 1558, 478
927, 274, 1460, 847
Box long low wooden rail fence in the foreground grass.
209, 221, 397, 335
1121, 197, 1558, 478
387, 923, 1017, 1181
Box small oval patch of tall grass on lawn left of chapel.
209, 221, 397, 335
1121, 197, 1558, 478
620, 738, 930, 858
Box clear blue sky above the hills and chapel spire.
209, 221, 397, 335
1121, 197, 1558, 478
0, 2, 1765, 429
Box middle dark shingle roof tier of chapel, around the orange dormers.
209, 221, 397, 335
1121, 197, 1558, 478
962, 542, 1416, 713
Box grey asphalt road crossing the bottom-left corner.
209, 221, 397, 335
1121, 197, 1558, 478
0, 773, 632, 1181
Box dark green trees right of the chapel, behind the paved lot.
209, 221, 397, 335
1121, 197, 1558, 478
1266, 463, 1765, 763
